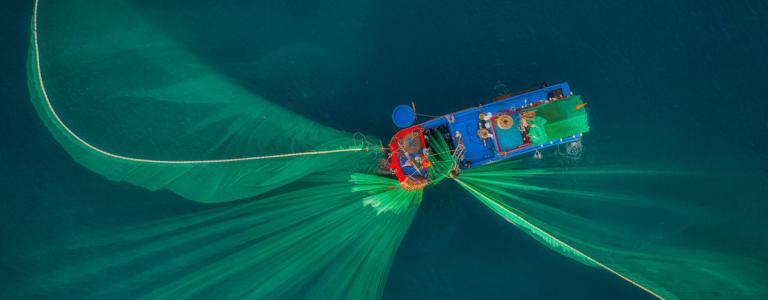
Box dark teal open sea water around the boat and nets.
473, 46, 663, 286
0, 1, 768, 299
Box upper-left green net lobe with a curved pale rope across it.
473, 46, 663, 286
29, 0, 378, 202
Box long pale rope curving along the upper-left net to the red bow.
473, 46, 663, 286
32, 0, 369, 164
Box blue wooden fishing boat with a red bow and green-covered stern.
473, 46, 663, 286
386, 82, 589, 190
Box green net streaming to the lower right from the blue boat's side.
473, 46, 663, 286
458, 159, 768, 299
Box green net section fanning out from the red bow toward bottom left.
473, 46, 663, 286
7, 173, 421, 299
